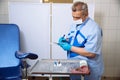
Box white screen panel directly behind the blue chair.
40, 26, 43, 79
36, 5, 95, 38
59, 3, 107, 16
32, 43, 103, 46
9, 2, 50, 59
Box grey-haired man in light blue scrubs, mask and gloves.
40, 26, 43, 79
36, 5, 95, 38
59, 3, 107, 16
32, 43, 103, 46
59, 1, 103, 80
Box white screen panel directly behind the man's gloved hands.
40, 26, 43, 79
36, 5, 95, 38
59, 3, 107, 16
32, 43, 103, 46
52, 4, 72, 59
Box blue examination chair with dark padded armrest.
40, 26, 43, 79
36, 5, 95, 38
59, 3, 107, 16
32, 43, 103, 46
0, 24, 38, 80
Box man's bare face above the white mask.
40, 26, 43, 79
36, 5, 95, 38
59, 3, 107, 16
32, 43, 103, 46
72, 7, 82, 21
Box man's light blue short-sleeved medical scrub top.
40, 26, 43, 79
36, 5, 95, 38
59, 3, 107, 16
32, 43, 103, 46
67, 17, 104, 74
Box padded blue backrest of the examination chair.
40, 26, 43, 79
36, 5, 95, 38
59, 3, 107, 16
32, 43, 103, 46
0, 24, 20, 67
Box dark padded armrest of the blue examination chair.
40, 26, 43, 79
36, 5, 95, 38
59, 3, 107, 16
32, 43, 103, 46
15, 51, 38, 59
